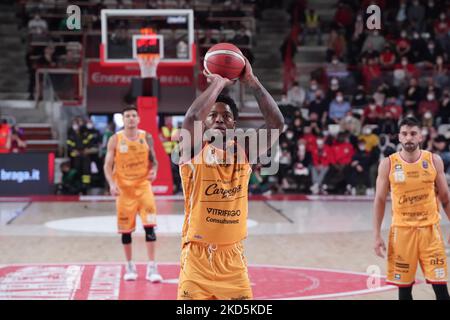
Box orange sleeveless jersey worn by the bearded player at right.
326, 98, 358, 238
389, 150, 441, 227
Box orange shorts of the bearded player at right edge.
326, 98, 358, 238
386, 224, 448, 286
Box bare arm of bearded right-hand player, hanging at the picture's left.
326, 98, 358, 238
373, 158, 391, 258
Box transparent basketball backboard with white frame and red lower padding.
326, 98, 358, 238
100, 9, 196, 66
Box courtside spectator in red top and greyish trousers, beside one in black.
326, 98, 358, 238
311, 137, 334, 194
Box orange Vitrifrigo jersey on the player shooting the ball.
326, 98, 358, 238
180, 144, 251, 244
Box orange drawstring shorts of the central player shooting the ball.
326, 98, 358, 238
178, 242, 253, 300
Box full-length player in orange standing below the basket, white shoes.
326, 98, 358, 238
104, 107, 162, 282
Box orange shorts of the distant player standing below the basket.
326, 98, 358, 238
116, 184, 156, 233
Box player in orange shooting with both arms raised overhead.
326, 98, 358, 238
178, 55, 284, 300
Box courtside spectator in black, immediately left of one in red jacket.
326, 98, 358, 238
293, 139, 312, 193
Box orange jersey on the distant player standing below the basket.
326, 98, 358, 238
114, 130, 149, 188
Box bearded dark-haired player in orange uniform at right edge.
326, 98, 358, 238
374, 117, 450, 300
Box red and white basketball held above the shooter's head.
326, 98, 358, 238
203, 43, 245, 80
